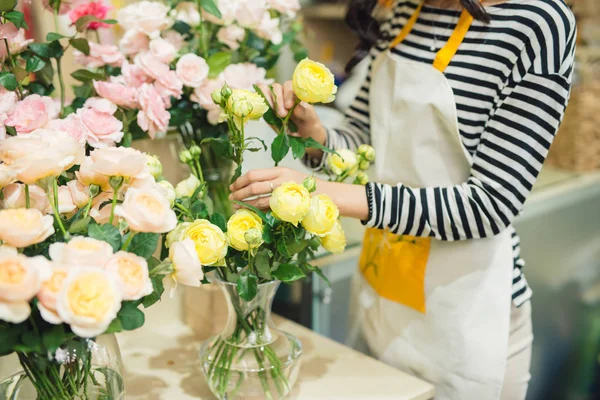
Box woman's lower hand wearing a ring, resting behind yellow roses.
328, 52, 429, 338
229, 167, 307, 210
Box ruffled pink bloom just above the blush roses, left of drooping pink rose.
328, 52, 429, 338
77, 97, 124, 148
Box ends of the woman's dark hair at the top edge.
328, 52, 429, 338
346, 0, 490, 72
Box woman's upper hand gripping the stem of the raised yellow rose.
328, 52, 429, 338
258, 81, 327, 152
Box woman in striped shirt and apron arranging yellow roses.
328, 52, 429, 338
232, 0, 576, 400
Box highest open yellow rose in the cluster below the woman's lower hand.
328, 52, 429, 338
269, 182, 310, 226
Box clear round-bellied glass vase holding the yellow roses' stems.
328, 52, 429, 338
200, 279, 302, 400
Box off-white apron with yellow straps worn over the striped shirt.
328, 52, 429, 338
352, 2, 513, 400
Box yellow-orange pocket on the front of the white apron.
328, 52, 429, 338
360, 229, 431, 313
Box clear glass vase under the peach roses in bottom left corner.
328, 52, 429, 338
0, 334, 125, 400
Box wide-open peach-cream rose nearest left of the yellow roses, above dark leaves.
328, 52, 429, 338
115, 186, 177, 233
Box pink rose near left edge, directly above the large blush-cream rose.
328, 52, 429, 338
5, 94, 60, 134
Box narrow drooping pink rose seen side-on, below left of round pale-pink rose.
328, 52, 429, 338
137, 84, 171, 139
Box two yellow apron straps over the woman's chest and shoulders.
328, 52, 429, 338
390, 1, 480, 72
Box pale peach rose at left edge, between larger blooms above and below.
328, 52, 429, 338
0, 208, 54, 247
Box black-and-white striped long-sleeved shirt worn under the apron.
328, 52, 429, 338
312, 0, 576, 306
